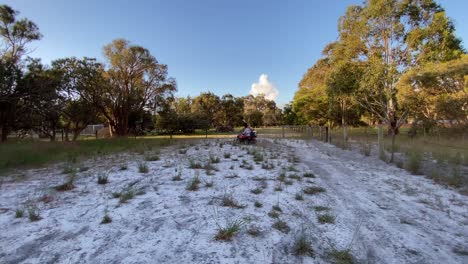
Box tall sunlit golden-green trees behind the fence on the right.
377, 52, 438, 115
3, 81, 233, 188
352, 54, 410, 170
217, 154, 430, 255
289, 0, 468, 157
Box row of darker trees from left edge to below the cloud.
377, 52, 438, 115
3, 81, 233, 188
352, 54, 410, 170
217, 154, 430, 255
0, 5, 282, 142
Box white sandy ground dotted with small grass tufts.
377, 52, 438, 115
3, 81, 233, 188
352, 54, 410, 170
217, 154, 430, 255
0, 140, 468, 264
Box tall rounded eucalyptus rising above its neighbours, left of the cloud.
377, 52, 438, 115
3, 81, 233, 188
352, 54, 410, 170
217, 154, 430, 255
100, 39, 176, 136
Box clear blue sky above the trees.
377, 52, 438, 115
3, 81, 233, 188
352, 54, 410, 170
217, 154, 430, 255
2, 0, 468, 104
